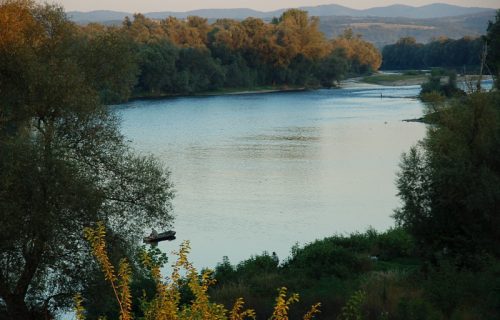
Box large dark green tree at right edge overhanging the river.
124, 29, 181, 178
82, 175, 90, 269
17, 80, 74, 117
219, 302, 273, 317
395, 93, 500, 267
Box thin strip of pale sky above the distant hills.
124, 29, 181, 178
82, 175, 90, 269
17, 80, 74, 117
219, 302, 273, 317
47, 0, 500, 12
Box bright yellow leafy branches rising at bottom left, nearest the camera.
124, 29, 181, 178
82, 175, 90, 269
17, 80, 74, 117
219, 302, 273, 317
80, 223, 320, 320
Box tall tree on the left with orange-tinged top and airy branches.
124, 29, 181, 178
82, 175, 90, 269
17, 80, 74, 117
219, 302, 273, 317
0, 0, 173, 319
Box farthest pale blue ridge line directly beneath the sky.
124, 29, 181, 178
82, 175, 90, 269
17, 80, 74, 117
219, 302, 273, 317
68, 3, 492, 23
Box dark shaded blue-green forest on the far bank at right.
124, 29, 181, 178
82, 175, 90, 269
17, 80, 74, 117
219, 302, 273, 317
382, 37, 484, 72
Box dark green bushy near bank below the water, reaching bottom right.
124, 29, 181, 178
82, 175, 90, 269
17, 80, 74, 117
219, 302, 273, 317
210, 228, 500, 319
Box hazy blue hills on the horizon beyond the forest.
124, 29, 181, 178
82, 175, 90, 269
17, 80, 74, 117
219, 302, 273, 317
67, 3, 496, 48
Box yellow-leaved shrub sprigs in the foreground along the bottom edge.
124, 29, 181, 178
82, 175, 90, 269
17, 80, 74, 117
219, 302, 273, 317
74, 222, 322, 320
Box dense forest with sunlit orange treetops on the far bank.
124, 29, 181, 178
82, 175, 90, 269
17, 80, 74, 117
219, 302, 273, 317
79, 9, 381, 102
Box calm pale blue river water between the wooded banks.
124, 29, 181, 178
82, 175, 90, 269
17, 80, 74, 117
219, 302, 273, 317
117, 86, 425, 267
